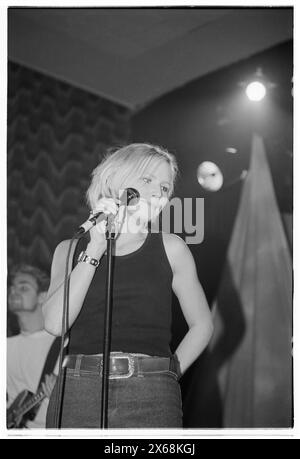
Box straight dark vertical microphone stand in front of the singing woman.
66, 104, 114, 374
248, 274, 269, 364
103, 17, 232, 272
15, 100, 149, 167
101, 215, 116, 429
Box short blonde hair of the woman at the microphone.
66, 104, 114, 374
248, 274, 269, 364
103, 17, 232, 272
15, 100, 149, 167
86, 143, 178, 209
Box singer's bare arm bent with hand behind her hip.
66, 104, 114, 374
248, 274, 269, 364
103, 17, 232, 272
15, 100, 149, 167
163, 234, 213, 374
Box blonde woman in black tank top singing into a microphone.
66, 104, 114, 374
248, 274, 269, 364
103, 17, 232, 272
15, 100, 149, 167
44, 143, 212, 428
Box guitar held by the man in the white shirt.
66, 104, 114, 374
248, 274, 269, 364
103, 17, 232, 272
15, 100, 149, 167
6, 390, 46, 429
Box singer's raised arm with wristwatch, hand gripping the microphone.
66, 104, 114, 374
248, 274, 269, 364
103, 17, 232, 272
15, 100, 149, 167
43, 238, 106, 336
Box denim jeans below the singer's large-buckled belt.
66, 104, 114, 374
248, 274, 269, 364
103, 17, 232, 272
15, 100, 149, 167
46, 358, 182, 429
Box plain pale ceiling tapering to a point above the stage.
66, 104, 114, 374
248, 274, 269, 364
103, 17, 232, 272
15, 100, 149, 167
8, 7, 293, 110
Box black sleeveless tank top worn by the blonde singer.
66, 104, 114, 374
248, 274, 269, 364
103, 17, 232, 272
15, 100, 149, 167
69, 232, 173, 357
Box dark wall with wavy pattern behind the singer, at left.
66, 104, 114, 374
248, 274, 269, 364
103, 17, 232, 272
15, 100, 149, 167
7, 62, 130, 269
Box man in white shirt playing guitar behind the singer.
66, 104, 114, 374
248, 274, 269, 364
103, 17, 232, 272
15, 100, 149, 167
7, 265, 56, 428
